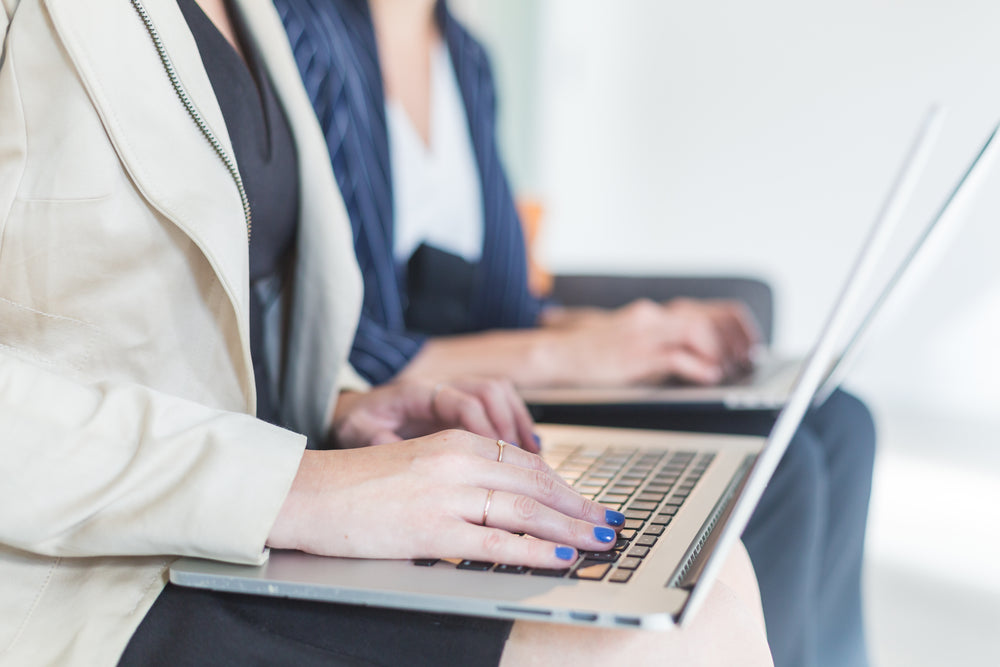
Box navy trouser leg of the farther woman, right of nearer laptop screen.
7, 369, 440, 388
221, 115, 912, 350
743, 391, 875, 667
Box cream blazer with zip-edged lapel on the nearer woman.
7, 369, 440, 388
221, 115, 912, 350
0, 0, 361, 665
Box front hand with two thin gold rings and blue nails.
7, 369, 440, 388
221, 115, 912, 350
268, 431, 624, 568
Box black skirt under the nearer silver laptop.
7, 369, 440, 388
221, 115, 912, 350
118, 584, 512, 667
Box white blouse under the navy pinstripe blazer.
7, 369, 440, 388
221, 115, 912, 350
386, 43, 483, 263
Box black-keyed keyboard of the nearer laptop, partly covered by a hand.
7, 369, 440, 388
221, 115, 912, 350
413, 446, 715, 584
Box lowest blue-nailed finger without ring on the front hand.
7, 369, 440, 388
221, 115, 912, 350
440, 521, 577, 570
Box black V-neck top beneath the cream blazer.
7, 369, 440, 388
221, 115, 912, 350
177, 0, 299, 423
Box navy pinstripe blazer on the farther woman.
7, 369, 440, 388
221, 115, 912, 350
274, 0, 541, 384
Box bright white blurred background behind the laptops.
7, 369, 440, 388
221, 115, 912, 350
456, 0, 1000, 665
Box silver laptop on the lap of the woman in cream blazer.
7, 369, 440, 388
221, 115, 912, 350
170, 107, 989, 628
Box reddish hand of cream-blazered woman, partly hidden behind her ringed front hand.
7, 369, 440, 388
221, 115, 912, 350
331, 378, 538, 452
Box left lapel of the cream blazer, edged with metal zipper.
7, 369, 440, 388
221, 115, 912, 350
44, 0, 253, 352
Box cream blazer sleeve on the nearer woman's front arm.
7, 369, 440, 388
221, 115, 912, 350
0, 350, 305, 563
